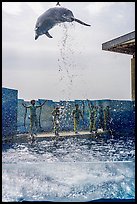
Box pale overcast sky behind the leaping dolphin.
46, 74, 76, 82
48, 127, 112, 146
2, 2, 135, 101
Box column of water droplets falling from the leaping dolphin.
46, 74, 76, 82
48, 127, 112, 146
58, 23, 76, 99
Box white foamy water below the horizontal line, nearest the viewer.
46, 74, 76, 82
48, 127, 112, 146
2, 162, 135, 202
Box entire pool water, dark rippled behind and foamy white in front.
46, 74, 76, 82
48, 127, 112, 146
2, 134, 135, 202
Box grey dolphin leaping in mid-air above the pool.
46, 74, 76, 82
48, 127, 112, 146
35, 6, 90, 40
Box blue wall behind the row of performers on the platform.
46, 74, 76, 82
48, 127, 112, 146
2, 88, 135, 137
